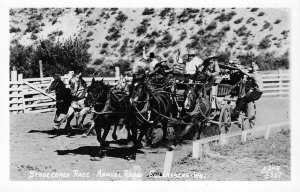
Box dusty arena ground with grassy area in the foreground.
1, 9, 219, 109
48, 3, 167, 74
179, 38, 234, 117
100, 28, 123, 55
10, 99, 290, 180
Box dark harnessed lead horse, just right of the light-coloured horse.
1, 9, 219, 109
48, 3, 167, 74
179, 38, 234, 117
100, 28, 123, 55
85, 78, 129, 157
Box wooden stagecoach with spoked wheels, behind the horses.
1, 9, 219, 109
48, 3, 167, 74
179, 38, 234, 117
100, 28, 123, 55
172, 64, 256, 133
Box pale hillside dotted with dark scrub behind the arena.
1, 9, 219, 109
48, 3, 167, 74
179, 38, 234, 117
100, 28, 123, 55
10, 8, 290, 73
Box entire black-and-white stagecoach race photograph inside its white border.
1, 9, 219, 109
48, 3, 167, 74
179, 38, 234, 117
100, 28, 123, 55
3, 1, 299, 189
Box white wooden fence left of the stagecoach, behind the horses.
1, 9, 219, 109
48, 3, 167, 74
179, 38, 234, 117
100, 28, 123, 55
9, 71, 120, 114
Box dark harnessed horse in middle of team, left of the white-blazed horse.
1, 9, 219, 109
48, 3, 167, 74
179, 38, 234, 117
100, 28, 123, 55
130, 74, 175, 148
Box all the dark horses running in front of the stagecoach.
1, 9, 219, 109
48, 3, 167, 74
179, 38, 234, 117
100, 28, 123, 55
47, 70, 210, 157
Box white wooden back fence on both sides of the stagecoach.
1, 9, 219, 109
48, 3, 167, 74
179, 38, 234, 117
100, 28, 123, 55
9, 69, 290, 114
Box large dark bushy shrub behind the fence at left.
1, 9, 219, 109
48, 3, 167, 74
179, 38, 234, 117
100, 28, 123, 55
10, 38, 91, 78
